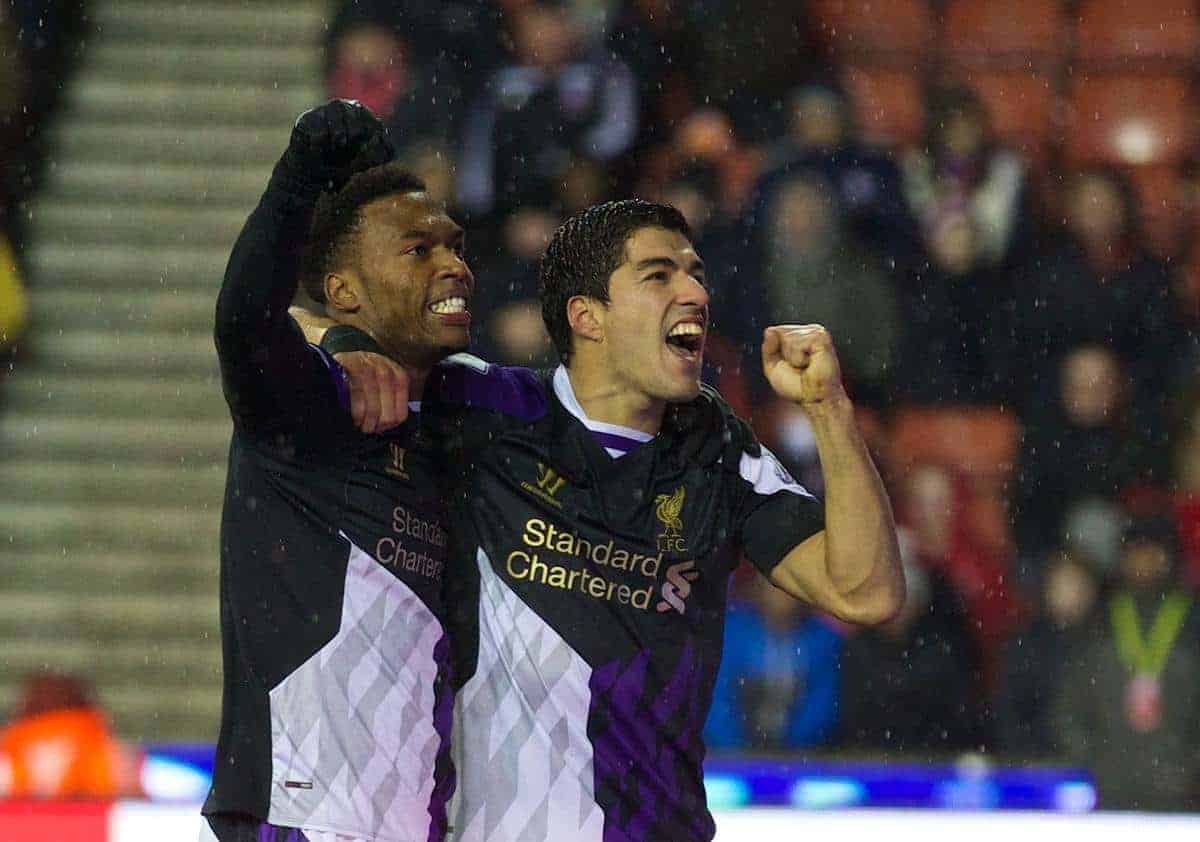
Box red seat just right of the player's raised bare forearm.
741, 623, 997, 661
889, 407, 1020, 480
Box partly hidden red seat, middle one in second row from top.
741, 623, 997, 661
960, 70, 1057, 163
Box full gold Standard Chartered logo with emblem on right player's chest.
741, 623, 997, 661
505, 518, 700, 614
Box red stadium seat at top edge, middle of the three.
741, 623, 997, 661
942, 0, 1067, 67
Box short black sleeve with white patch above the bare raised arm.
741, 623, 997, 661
738, 447, 824, 575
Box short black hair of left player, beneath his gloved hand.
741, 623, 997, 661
300, 162, 425, 303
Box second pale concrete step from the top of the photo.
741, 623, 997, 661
80, 40, 320, 85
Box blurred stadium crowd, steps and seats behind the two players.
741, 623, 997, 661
0, 0, 1200, 838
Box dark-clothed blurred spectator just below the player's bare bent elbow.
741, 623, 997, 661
840, 564, 982, 756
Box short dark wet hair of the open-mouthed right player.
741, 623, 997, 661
538, 199, 691, 363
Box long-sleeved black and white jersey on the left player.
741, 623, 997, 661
204, 193, 454, 842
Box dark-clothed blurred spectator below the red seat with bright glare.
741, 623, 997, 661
1010, 168, 1176, 422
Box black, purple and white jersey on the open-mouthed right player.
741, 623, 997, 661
426, 361, 823, 842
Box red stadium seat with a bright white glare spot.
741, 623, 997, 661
1064, 73, 1195, 167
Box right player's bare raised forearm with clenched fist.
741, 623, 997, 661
762, 325, 905, 624
